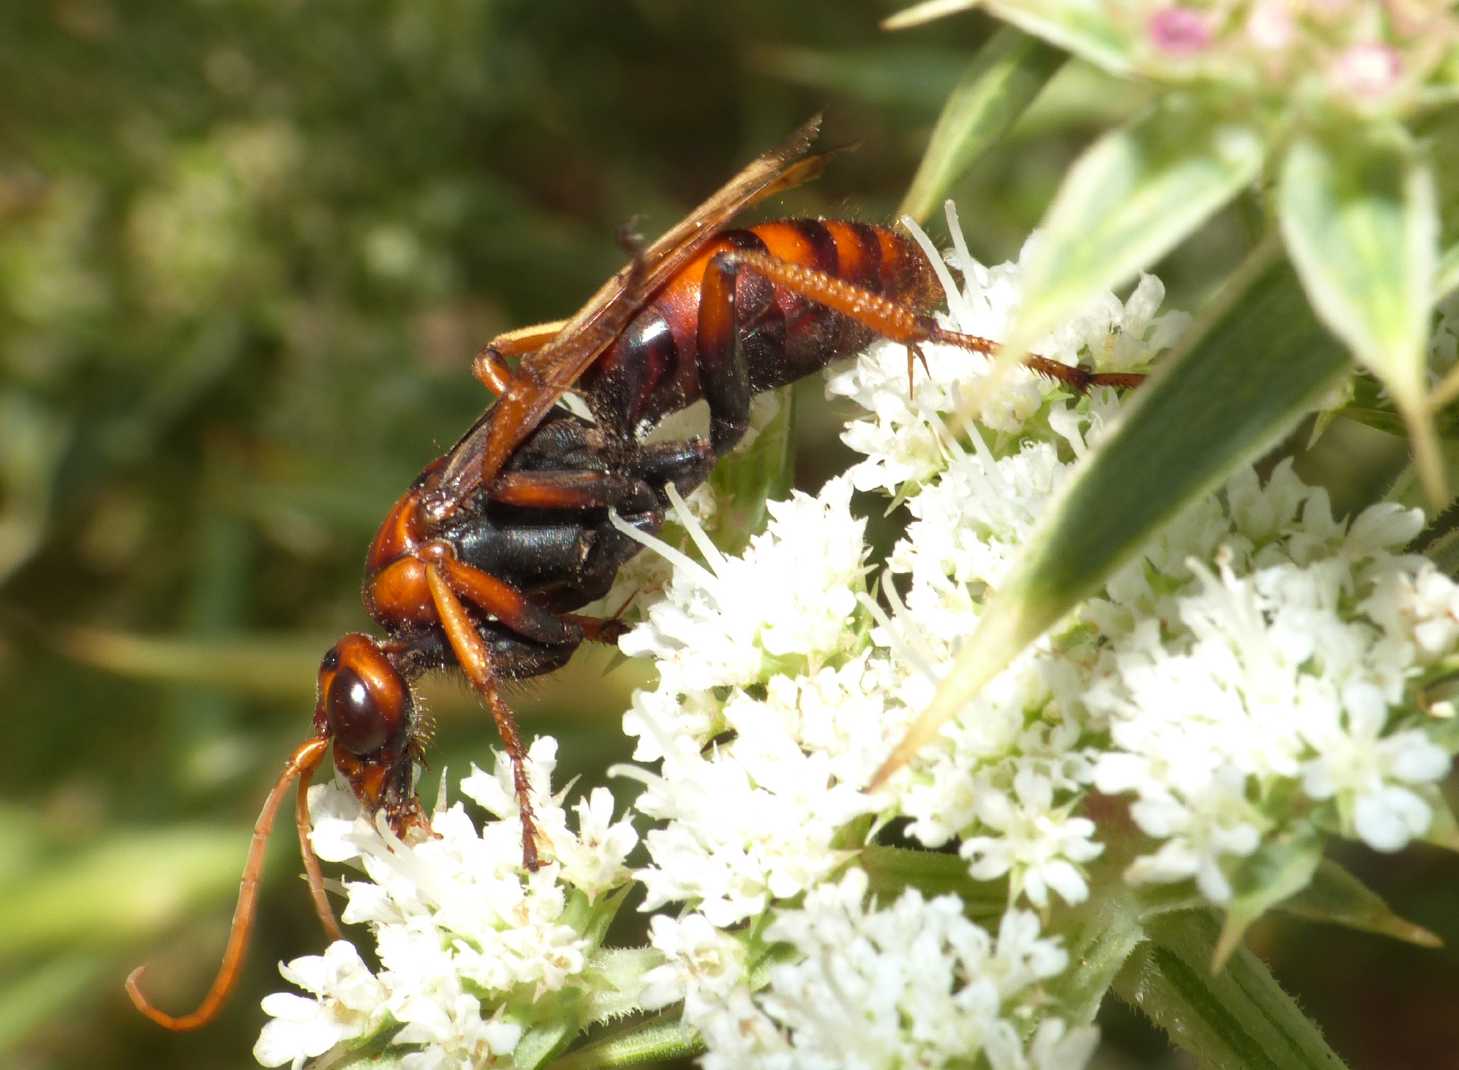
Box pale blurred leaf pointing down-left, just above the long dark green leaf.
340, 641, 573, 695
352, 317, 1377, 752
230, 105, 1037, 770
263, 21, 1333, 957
1004, 95, 1263, 353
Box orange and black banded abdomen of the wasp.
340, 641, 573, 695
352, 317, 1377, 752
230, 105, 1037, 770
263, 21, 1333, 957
578, 219, 935, 432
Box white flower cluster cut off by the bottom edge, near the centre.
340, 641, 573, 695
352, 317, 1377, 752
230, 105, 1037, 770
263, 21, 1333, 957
648, 869, 1097, 1070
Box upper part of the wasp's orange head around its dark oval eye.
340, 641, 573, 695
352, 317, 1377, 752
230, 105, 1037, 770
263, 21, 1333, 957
314, 634, 410, 758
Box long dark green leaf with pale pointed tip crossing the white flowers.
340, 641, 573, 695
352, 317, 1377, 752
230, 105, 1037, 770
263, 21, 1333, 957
874, 247, 1348, 782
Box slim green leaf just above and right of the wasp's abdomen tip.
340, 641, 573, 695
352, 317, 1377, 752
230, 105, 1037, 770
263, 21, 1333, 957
900, 29, 1064, 222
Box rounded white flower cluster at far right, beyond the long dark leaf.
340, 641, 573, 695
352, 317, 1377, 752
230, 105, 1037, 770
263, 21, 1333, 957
1085, 461, 1459, 902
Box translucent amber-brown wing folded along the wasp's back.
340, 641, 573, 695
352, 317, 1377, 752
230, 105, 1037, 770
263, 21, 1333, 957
426, 115, 829, 520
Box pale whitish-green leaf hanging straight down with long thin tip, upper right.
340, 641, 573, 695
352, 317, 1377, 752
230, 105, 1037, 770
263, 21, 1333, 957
1277, 126, 1447, 505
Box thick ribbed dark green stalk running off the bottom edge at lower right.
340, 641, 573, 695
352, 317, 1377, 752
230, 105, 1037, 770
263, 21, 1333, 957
1115, 912, 1342, 1070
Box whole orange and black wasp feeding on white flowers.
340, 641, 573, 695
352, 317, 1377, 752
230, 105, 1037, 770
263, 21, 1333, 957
127, 117, 1141, 1031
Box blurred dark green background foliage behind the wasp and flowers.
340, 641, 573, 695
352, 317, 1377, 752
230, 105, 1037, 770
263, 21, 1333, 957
0, 0, 1459, 1069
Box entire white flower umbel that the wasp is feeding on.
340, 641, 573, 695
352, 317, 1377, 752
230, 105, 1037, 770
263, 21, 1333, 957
255, 204, 1459, 1070
